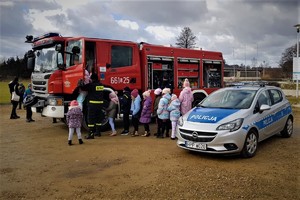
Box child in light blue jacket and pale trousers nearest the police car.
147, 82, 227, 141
168, 94, 180, 140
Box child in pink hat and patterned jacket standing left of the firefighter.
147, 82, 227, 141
66, 100, 83, 145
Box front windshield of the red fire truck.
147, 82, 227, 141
34, 47, 63, 73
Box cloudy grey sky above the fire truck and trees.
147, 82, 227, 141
0, 0, 300, 67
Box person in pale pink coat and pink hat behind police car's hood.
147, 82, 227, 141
178, 78, 194, 115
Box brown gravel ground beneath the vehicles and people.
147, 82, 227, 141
0, 105, 300, 200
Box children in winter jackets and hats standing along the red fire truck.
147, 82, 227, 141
66, 79, 193, 145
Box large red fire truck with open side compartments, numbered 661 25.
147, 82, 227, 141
26, 33, 224, 130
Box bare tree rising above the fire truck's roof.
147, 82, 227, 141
176, 27, 197, 49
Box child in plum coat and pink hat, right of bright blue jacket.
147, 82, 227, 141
140, 91, 152, 137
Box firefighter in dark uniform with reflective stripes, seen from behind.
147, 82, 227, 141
80, 73, 104, 139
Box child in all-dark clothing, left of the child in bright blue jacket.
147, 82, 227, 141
121, 87, 131, 135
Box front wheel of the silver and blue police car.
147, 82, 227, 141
241, 129, 258, 158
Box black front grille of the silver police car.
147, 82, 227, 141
179, 129, 217, 142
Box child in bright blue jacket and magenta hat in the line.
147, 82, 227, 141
130, 89, 142, 137
